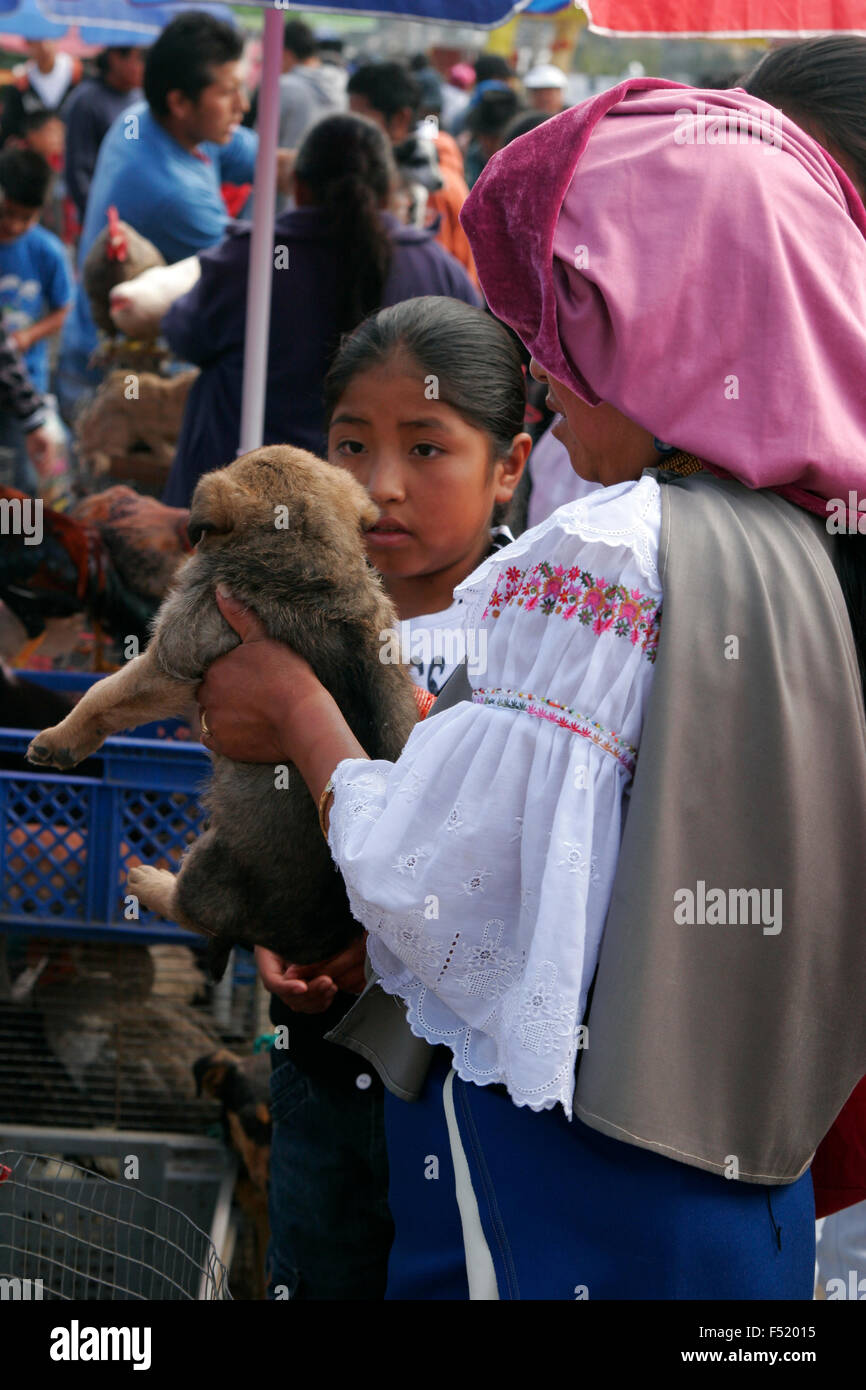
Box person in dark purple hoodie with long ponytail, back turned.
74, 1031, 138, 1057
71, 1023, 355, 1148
163, 114, 481, 507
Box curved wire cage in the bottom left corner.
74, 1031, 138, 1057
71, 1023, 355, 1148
0, 1150, 231, 1301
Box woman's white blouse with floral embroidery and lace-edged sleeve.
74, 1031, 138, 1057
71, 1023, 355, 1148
329, 470, 662, 1115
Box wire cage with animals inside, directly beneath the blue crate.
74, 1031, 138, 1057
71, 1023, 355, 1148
0, 934, 267, 1134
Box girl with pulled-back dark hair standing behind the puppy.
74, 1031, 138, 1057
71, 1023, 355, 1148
241, 296, 531, 1298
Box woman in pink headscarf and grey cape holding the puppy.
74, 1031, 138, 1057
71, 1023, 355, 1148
198, 78, 866, 1298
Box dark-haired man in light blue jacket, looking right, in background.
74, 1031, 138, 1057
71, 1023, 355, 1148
58, 11, 289, 420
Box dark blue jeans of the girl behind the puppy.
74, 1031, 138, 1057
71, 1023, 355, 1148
267, 1044, 393, 1300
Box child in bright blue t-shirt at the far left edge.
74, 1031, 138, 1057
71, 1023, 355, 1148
0, 149, 72, 493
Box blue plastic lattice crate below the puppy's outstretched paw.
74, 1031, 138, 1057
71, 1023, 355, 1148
0, 671, 210, 945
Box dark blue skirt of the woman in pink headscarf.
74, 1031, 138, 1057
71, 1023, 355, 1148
385, 1049, 815, 1300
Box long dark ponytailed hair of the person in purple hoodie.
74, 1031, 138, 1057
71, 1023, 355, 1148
295, 114, 395, 335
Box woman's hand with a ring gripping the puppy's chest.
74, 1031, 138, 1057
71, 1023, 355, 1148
196, 589, 325, 763
